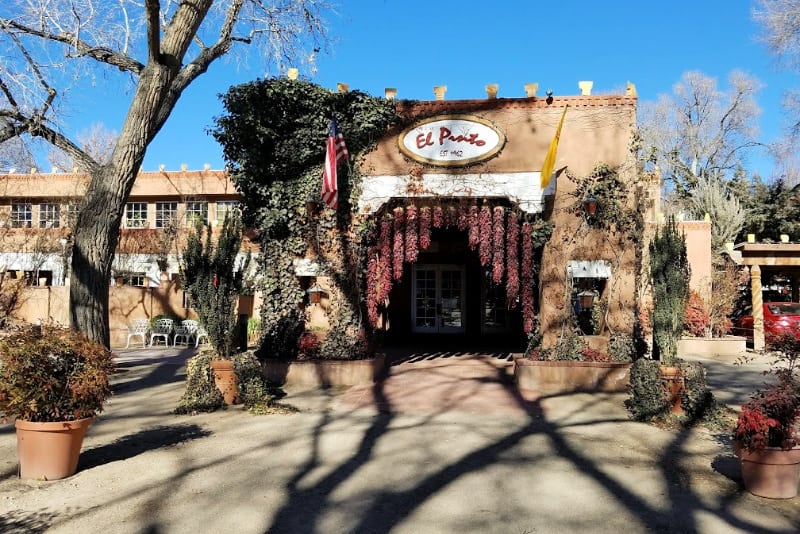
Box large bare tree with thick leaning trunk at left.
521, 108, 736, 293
0, 0, 329, 345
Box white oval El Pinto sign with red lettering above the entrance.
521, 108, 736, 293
397, 115, 506, 167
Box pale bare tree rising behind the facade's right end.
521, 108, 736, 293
639, 71, 761, 200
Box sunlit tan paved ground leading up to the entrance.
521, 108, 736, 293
0, 349, 800, 534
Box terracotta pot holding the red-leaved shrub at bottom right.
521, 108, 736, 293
733, 443, 800, 499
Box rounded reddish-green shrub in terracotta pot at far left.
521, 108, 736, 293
0, 325, 114, 480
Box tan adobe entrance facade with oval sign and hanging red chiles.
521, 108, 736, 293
298, 82, 657, 347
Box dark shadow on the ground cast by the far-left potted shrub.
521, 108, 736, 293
78, 424, 211, 471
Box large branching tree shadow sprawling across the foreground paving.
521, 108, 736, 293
266, 359, 792, 534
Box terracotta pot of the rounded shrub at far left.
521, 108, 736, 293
14, 417, 94, 480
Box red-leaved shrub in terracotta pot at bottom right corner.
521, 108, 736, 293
733, 336, 800, 499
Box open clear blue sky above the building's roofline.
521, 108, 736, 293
73, 0, 800, 177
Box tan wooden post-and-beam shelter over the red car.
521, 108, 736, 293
735, 243, 800, 350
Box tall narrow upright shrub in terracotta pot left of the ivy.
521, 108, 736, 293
181, 210, 250, 404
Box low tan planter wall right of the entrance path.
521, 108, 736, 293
514, 357, 631, 395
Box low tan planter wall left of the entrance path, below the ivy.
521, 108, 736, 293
264, 354, 386, 387
